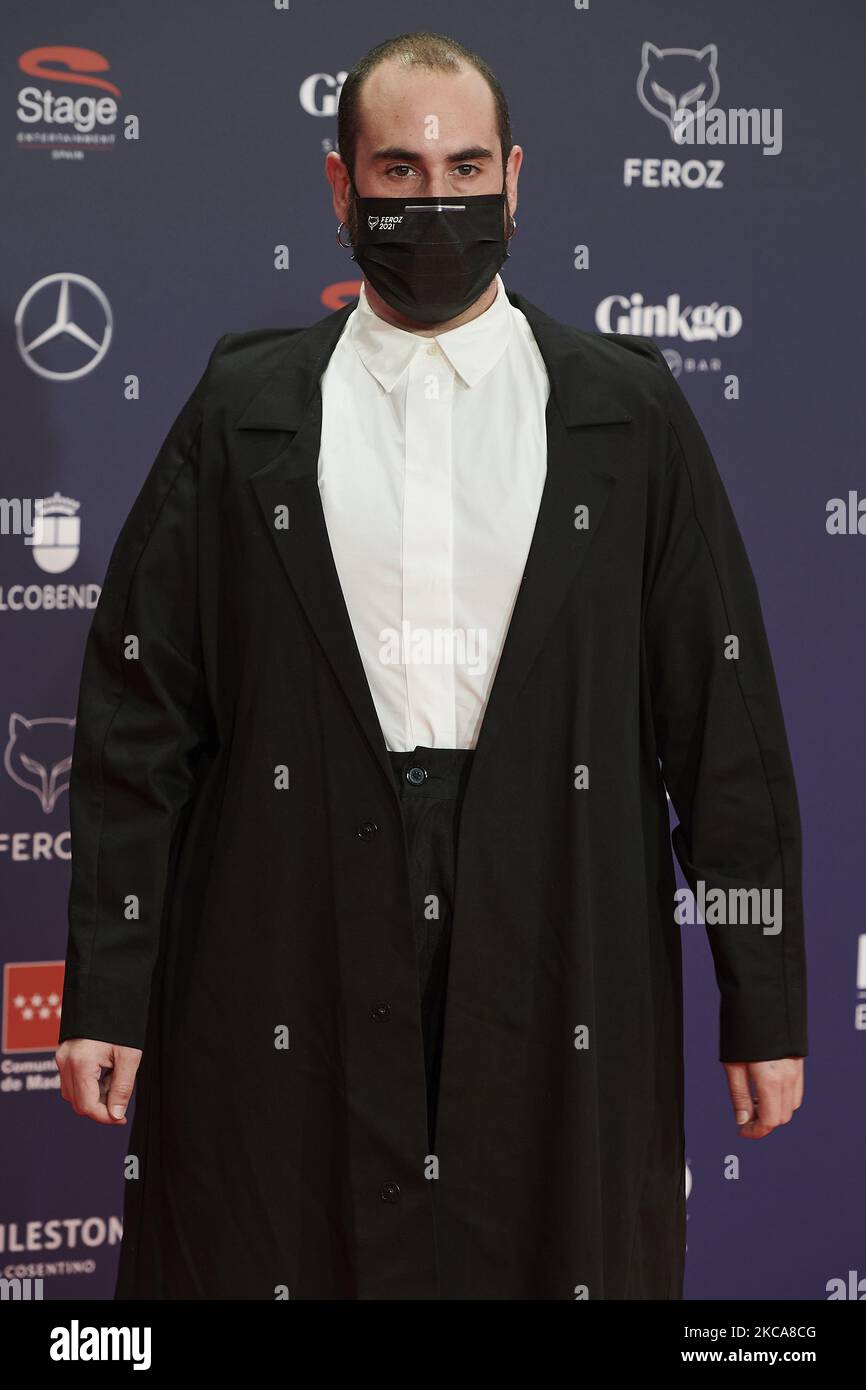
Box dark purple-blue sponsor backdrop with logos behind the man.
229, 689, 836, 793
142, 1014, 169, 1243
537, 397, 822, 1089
0, 0, 866, 1300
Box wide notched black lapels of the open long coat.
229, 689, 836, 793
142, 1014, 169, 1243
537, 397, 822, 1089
235, 291, 631, 795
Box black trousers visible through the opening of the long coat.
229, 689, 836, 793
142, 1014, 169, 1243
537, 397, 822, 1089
389, 744, 474, 1154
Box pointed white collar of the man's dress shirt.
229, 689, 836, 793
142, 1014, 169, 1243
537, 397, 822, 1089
348, 275, 512, 391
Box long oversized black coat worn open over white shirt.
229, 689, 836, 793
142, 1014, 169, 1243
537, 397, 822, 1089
60, 291, 806, 1300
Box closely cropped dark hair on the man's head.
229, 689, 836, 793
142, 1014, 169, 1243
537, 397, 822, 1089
336, 29, 513, 181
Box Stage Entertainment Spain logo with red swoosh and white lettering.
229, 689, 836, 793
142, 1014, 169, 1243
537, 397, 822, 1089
15, 43, 127, 160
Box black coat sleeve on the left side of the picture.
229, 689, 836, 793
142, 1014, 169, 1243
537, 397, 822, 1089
60, 334, 231, 1048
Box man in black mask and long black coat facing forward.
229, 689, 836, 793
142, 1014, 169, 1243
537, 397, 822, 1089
57, 33, 806, 1300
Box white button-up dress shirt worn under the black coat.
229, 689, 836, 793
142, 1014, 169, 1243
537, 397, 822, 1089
318, 275, 550, 752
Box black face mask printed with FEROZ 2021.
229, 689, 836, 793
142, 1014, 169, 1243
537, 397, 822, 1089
352, 183, 509, 324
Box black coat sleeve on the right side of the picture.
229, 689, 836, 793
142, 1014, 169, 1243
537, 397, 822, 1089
644, 345, 808, 1062
